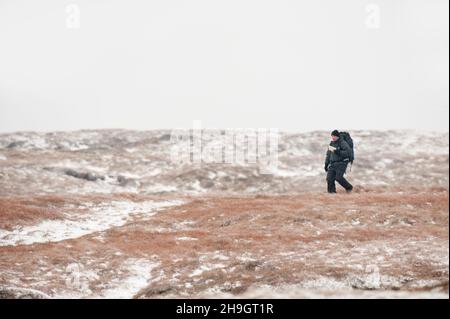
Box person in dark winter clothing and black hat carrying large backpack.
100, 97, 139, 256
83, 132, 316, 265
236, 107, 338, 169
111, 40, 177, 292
325, 130, 353, 193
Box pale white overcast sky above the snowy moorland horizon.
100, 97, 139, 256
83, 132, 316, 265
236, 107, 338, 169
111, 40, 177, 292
0, 0, 449, 132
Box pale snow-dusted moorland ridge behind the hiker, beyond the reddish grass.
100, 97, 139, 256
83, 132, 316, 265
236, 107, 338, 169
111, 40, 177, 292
0, 130, 449, 195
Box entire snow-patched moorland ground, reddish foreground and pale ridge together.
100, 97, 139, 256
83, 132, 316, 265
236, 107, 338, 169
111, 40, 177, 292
0, 130, 449, 298
